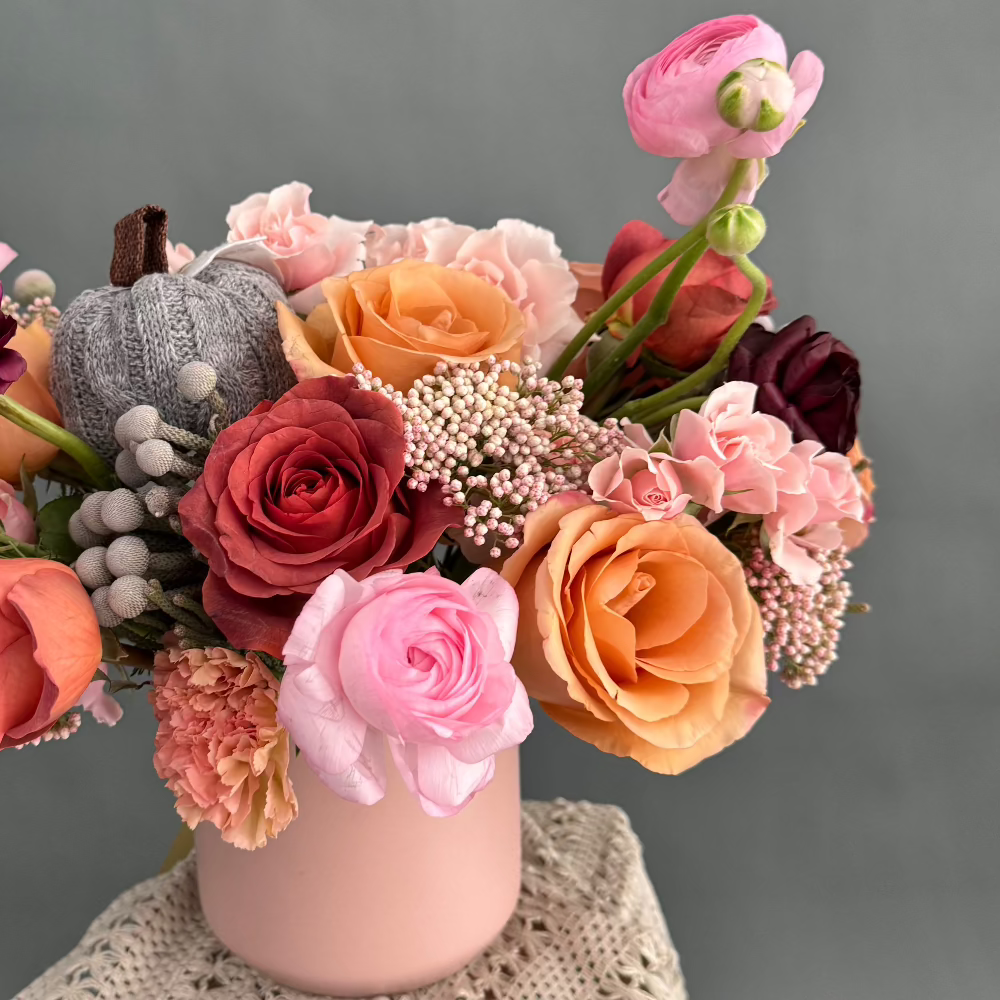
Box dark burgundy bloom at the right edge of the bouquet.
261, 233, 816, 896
727, 316, 861, 455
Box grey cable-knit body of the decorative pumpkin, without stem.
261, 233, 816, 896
52, 260, 295, 461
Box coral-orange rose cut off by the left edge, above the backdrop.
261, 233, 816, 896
0, 559, 101, 750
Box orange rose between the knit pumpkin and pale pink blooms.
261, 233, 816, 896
278, 260, 524, 391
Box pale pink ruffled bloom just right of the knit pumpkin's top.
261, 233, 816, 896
226, 181, 371, 312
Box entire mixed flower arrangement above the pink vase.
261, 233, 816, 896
0, 15, 874, 848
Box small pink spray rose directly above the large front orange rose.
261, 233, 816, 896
589, 448, 691, 521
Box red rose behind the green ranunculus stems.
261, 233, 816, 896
601, 220, 778, 371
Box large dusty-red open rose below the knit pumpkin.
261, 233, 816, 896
179, 375, 456, 656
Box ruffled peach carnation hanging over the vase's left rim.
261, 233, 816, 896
150, 648, 299, 850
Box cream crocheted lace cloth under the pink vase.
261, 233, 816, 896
15, 800, 687, 1000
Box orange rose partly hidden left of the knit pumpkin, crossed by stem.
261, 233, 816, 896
0, 319, 62, 486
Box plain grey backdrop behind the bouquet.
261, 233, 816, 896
0, 0, 1000, 1000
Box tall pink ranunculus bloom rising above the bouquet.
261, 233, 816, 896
624, 14, 823, 226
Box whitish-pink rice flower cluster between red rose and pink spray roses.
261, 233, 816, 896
354, 357, 628, 559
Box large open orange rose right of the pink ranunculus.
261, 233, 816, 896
501, 493, 769, 774
